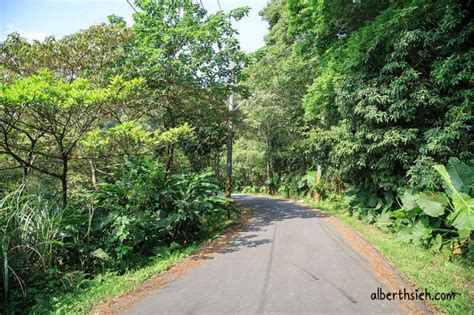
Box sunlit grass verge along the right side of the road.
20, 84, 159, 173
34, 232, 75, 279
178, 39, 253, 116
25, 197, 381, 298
241, 194, 474, 315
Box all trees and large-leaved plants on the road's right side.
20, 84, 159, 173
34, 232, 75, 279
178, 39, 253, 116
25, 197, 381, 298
235, 0, 474, 257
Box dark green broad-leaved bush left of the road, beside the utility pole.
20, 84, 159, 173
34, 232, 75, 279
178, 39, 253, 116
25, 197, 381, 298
82, 158, 230, 261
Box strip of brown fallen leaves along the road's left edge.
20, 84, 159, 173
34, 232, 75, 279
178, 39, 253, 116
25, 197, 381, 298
88, 204, 252, 315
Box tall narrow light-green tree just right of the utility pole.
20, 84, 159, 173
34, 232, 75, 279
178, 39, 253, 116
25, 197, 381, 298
238, 1, 314, 185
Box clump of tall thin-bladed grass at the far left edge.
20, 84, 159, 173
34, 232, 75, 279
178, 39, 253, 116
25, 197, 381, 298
0, 186, 63, 305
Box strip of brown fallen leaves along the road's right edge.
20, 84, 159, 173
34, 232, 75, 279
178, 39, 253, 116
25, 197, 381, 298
307, 207, 434, 314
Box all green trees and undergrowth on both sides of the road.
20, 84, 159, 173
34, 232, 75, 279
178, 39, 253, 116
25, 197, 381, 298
0, 0, 474, 313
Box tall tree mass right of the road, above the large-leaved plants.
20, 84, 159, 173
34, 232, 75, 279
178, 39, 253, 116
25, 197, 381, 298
239, 0, 473, 194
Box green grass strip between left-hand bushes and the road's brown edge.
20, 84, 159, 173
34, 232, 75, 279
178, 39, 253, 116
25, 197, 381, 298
33, 211, 239, 314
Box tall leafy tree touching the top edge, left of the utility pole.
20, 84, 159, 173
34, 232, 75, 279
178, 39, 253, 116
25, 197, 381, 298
125, 0, 248, 170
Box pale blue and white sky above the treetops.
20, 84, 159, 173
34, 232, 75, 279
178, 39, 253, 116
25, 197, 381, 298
0, 0, 268, 52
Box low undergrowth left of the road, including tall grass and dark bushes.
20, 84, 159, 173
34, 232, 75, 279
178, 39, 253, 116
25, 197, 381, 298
0, 158, 237, 310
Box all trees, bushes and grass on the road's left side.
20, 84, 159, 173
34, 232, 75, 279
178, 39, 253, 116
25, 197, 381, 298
0, 0, 247, 313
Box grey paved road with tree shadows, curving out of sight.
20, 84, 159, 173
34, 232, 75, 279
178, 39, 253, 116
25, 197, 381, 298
124, 196, 402, 314
